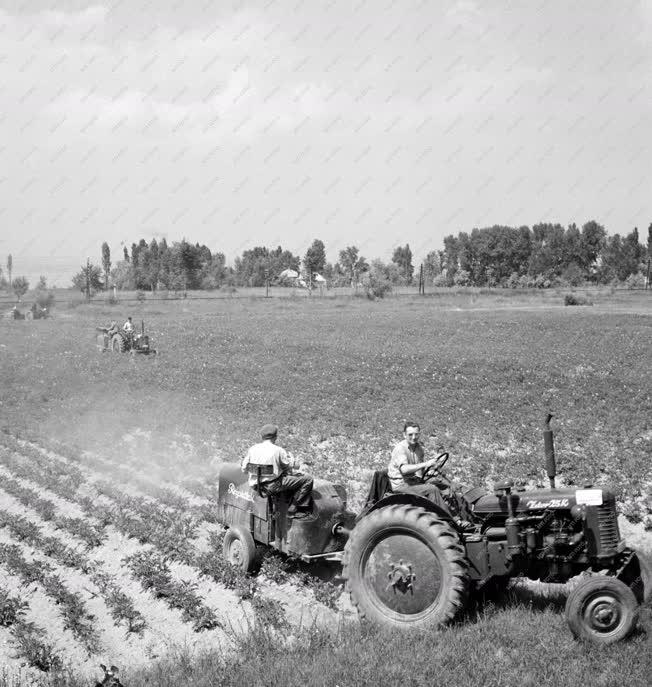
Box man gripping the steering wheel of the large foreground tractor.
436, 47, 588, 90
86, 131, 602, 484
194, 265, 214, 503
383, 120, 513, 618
387, 421, 470, 526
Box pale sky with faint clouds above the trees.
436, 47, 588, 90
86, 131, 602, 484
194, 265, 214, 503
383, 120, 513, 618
0, 0, 652, 286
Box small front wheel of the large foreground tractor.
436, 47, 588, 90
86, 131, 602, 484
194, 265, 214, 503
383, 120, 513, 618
565, 576, 638, 645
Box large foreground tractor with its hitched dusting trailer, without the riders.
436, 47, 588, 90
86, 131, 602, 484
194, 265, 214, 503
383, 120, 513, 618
217, 415, 652, 645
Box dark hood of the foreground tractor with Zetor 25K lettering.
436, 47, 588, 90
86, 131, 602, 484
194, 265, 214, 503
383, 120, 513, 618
473, 488, 614, 513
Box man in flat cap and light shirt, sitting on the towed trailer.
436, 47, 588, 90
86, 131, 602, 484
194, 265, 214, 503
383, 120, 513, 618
241, 425, 313, 518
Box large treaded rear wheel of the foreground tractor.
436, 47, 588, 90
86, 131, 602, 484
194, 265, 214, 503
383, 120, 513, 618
342, 505, 469, 629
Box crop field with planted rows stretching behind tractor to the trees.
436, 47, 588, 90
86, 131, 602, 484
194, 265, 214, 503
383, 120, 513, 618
0, 293, 652, 685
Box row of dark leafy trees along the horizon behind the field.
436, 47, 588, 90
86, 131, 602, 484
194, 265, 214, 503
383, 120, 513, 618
0, 220, 652, 299
